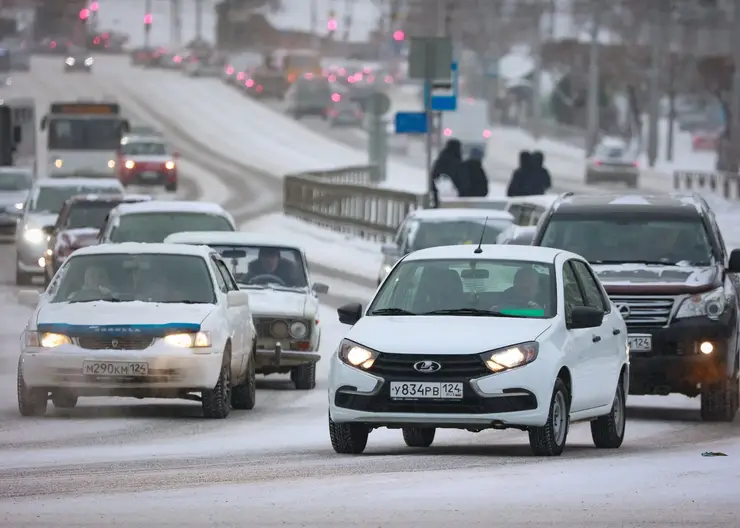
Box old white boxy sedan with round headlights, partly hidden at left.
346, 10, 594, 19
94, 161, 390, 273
165, 231, 329, 390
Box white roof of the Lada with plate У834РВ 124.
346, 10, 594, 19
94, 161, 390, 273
404, 244, 583, 264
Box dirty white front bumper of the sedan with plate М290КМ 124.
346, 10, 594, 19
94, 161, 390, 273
19, 341, 223, 396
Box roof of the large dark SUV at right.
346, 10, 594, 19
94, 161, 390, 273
555, 192, 703, 216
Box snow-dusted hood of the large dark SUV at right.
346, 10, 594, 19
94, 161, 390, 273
592, 264, 719, 294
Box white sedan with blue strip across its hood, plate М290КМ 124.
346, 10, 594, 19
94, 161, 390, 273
18, 243, 255, 418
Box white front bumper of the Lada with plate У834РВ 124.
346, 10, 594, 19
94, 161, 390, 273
329, 355, 554, 429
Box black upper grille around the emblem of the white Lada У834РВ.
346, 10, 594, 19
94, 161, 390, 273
368, 353, 491, 381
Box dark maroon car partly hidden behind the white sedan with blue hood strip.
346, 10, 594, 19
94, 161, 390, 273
44, 194, 152, 285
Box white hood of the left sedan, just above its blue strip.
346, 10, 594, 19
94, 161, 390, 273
36, 301, 214, 327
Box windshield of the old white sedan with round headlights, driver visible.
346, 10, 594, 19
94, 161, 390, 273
205, 245, 308, 288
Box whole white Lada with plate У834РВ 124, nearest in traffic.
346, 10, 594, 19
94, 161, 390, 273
329, 245, 629, 456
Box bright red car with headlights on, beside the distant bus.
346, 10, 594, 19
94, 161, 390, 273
116, 136, 179, 192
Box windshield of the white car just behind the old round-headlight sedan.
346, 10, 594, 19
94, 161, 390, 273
110, 212, 234, 243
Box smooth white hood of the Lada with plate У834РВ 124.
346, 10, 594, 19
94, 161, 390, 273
346, 315, 552, 354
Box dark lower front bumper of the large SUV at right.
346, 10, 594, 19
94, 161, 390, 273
628, 315, 736, 396
